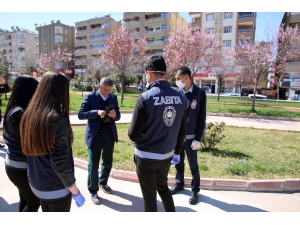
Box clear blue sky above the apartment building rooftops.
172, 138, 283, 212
0, 12, 284, 39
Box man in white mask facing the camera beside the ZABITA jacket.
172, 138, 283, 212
170, 67, 206, 205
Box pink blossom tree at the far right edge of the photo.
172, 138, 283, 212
270, 24, 300, 102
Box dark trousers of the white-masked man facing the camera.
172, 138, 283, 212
175, 139, 200, 192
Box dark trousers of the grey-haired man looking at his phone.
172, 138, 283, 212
87, 133, 115, 194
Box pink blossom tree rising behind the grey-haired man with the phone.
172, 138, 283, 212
103, 25, 147, 104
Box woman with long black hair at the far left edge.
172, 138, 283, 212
3, 75, 40, 212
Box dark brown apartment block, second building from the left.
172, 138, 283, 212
35, 20, 75, 78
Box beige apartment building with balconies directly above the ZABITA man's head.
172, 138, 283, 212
123, 12, 187, 54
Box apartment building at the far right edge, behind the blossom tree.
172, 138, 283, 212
279, 12, 300, 100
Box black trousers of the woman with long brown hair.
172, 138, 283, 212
41, 193, 72, 212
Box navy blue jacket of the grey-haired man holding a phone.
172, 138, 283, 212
78, 90, 121, 147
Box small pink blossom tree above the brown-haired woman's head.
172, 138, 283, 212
36, 46, 74, 73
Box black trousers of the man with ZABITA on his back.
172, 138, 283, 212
134, 157, 175, 212
